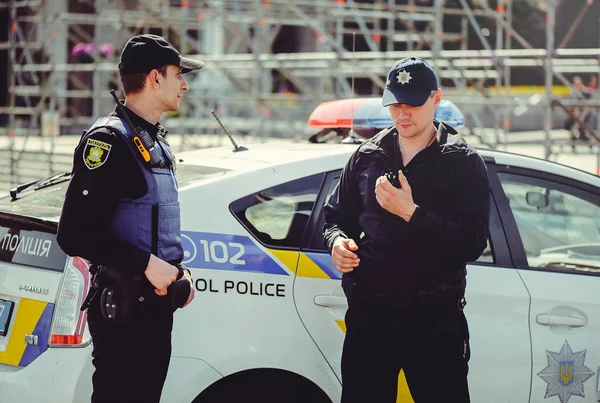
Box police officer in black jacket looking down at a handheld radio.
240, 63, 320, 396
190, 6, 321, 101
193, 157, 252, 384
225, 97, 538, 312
324, 57, 490, 403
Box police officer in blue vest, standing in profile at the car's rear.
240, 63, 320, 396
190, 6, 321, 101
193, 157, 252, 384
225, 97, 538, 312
58, 34, 203, 403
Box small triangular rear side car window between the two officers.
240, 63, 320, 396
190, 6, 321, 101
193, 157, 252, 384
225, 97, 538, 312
231, 174, 324, 248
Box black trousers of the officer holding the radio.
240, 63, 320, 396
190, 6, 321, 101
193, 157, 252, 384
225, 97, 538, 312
341, 298, 470, 403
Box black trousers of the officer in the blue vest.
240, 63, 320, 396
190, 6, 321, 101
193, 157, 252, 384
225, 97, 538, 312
88, 295, 173, 403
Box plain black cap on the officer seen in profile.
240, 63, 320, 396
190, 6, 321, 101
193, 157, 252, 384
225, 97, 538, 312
119, 34, 204, 76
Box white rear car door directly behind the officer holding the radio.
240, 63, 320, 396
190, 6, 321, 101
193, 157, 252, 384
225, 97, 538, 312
294, 166, 531, 403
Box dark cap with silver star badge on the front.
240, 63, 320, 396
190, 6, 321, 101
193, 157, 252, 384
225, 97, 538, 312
382, 57, 438, 106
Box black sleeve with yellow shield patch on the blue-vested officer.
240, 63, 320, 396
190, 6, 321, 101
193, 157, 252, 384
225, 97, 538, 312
57, 131, 150, 273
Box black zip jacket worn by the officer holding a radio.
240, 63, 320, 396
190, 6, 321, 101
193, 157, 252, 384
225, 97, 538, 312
324, 122, 490, 304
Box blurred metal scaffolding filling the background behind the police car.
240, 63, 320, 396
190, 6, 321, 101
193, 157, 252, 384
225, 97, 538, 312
0, 0, 600, 189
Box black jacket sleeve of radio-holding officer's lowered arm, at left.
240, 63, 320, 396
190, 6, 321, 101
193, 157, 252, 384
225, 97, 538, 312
323, 150, 362, 253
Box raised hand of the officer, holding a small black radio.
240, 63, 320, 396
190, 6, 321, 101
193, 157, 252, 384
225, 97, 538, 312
375, 171, 417, 222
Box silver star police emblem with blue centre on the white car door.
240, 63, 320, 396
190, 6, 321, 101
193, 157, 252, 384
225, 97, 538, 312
538, 340, 594, 403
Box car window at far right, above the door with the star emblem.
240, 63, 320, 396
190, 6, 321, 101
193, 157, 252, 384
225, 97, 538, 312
498, 173, 600, 273
